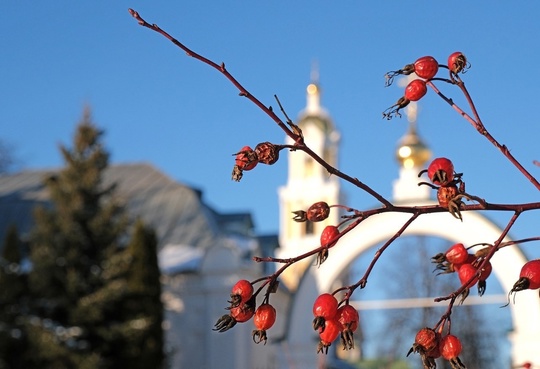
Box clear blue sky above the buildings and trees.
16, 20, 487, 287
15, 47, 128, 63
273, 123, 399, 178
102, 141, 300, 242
0, 0, 540, 248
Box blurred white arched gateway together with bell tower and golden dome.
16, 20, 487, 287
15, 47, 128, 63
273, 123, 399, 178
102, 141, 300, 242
277, 83, 540, 368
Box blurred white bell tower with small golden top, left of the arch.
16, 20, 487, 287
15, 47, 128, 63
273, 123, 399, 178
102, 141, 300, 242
277, 74, 342, 289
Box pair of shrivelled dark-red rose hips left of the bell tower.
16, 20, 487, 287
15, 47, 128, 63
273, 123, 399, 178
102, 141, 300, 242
232, 142, 282, 182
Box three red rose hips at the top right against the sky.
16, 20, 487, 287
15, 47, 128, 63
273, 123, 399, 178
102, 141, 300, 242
383, 51, 469, 119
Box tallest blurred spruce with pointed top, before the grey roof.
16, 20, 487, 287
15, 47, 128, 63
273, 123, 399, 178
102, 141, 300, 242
29, 109, 162, 369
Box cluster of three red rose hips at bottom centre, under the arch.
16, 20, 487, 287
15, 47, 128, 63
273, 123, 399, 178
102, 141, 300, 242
313, 293, 360, 354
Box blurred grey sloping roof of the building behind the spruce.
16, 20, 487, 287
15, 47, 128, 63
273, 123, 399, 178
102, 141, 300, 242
0, 164, 222, 248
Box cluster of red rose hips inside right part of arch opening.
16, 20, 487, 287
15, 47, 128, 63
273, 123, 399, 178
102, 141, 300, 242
431, 243, 493, 302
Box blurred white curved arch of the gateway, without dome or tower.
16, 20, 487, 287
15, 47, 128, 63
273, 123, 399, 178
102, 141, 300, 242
289, 207, 540, 365
